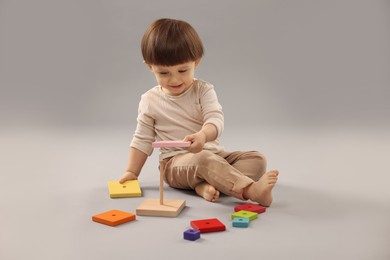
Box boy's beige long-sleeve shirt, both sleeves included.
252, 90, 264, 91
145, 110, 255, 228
130, 79, 224, 160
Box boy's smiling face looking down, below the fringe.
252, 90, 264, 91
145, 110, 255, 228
148, 61, 199, 96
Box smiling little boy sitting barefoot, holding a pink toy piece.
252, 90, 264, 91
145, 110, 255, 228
120, 19, 279, 206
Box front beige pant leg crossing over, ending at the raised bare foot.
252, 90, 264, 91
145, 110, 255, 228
160, 150, 253, 200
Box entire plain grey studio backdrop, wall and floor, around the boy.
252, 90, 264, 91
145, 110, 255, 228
0, 0, 390, 260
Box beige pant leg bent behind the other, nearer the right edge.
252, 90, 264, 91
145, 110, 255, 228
219, 151, 267, 181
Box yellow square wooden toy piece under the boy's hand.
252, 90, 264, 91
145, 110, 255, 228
108, 180, 142, 198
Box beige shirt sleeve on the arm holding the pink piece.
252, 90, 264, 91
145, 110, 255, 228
200, 83, 224, 137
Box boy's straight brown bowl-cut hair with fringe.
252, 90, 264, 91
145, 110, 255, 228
141, 18, 204, 66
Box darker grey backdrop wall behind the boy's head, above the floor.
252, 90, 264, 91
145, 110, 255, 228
0, 0, 390, 126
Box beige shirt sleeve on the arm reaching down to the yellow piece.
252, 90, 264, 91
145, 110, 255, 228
130, 95, 155, 156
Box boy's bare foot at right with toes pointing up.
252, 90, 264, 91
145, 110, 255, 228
243, 170, 279, 207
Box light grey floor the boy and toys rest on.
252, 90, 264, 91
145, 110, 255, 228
0, 127, 390, 260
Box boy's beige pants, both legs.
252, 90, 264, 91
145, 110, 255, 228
160, 150, 266, 200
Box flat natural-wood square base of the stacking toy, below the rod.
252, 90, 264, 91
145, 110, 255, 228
136, 199, 186, 217
